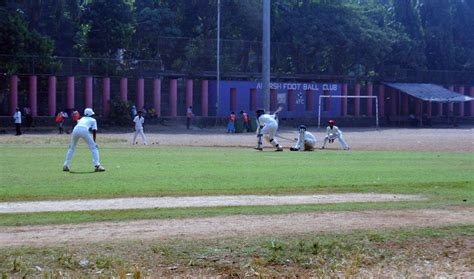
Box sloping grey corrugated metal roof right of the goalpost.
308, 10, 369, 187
385, 82, 474, 102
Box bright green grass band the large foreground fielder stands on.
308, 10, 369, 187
0, 146, 474, 201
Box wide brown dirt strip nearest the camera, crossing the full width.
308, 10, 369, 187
0, 208, 474, 247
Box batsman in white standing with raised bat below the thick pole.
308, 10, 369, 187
255, 109, 283, 151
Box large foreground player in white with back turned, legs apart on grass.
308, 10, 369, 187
63, 108, 105, 172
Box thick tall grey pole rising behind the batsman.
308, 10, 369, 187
262, 0, 270, 112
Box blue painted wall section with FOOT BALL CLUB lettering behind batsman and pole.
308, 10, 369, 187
209, 81, 341, 118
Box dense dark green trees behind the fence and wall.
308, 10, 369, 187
0, 0, 474, 76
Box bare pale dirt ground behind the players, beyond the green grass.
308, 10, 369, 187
0, 125, 474, 152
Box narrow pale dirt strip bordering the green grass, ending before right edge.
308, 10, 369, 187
0, 193, 424, 213
